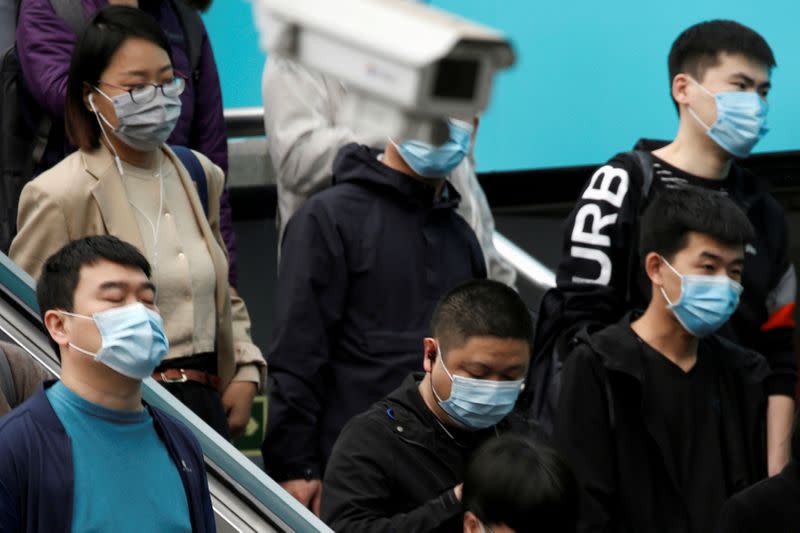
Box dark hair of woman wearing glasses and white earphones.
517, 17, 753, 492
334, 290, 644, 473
64, 6, 172, 150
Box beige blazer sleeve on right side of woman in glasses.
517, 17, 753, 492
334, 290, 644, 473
195, 152, 267, 386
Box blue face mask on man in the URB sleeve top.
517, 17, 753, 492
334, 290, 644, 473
689, 78, 769, 157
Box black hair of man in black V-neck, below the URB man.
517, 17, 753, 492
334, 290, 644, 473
639, 186, 755, 261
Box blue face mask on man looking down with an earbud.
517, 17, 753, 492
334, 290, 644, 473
431, 344, 525, 429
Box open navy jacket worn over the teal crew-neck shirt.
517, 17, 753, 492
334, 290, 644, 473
0, 381, 216, 533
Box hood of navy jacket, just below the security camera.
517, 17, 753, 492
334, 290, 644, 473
333, 143, 461, 208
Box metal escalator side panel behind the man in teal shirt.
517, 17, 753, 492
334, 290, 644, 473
0, 253, 331, 533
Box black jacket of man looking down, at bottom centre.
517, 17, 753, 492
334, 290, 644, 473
321, 372, 537, 533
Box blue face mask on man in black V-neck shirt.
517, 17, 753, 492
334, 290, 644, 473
661, 257, 742, 337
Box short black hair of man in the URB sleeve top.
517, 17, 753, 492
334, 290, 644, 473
668, 20, 776, 107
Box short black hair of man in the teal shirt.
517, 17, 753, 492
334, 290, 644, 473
36, 235, 150, 320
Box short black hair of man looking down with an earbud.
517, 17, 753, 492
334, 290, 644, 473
431, 280, 533, 352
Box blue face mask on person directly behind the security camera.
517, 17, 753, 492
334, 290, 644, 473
394, 119, 472, 178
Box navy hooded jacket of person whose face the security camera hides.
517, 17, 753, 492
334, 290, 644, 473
262, 144, 486, 480
